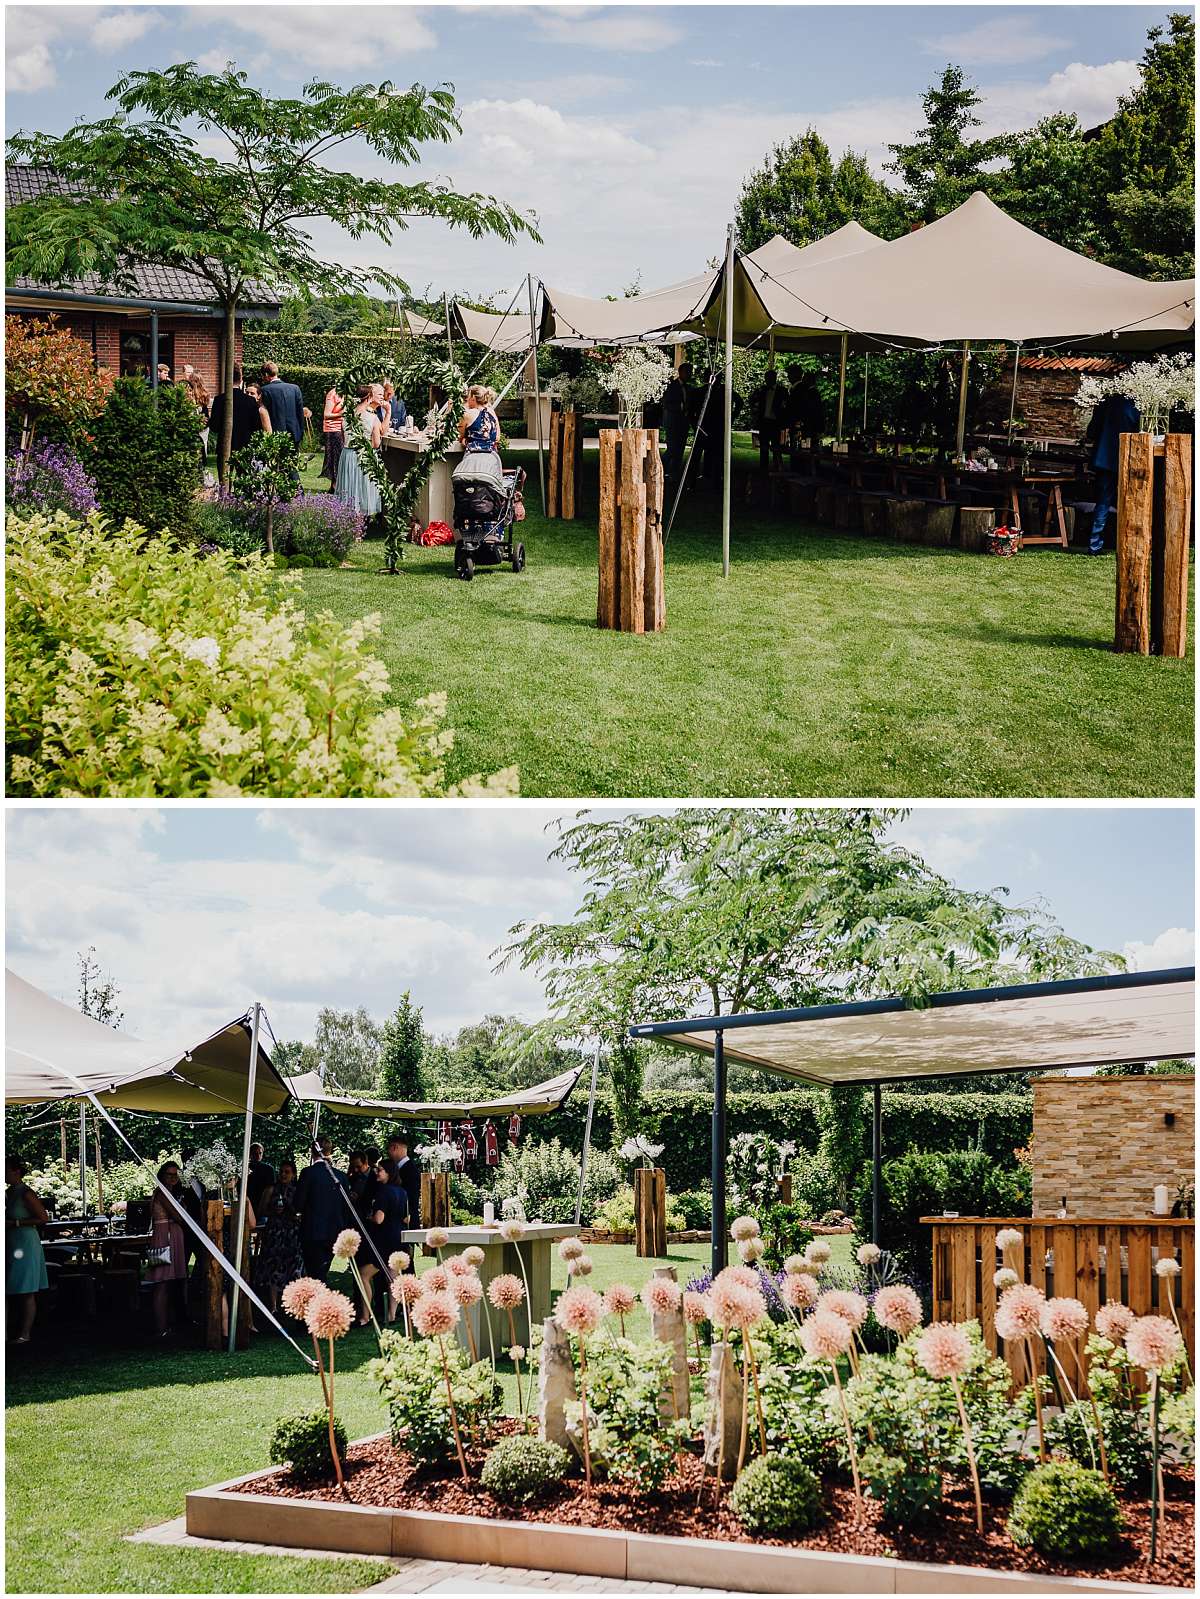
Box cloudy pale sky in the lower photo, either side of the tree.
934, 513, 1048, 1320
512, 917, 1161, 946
6, 804, 1195, 1038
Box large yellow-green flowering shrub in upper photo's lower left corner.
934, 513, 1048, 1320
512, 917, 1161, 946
5, 512, 521, 799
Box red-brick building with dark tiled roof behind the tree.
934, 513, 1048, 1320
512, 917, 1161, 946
5, 166, 278, 393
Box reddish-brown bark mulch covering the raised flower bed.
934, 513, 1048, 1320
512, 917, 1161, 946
237, 1425, 1195, 1588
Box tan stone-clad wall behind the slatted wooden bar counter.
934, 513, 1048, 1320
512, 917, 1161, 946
1034, 1076, 1195, 1217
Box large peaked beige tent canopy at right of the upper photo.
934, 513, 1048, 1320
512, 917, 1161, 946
704, 192, 1195, 350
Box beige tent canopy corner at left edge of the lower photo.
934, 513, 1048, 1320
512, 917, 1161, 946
5, 969, 290, 1116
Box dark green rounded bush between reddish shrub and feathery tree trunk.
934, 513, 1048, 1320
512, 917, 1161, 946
86, 377, 200, 534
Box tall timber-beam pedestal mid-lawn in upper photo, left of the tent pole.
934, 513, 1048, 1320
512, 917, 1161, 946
595, 427, 667, 633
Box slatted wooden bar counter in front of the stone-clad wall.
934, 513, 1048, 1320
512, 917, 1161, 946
922, 1215, 1195, 1382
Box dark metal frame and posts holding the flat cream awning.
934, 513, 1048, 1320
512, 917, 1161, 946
629, 966, 1195, 1276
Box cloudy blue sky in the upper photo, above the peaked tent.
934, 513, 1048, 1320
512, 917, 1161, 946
6, 3, 1166, 301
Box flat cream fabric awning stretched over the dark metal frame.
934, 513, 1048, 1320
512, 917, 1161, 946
630, 966, 1195, 1087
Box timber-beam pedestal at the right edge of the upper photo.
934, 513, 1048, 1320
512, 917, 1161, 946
1114, 433, 1192, 659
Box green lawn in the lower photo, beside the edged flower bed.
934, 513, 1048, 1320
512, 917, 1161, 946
5, 1238, 850, 1593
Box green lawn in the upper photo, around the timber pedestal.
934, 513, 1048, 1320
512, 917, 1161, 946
294, 454, 1194, 798
